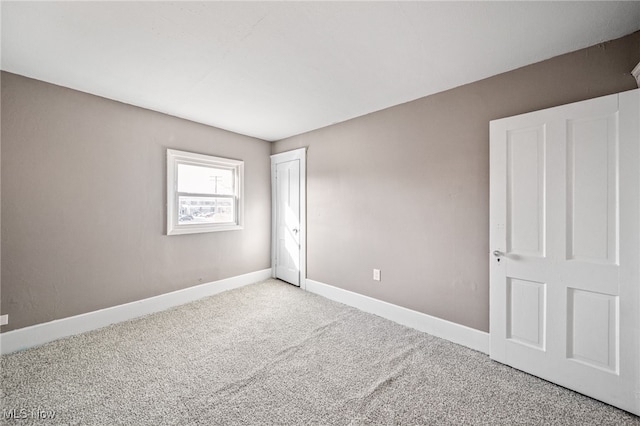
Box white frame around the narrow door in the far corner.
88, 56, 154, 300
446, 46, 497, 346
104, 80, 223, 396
271, 147, 307, 290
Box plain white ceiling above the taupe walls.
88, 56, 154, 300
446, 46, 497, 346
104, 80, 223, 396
1, 1, 640, 141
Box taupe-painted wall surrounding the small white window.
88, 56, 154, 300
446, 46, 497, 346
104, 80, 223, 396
0, 72, 271, 331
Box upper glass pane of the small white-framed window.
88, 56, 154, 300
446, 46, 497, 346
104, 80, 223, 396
178, 164, 234, 195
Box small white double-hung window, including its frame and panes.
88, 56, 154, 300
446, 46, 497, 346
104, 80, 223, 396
167, 149, 244, 235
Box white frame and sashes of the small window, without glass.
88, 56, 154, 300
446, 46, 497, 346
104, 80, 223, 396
167, 149, 244, 235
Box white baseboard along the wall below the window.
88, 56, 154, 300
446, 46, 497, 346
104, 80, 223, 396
0, 268, 271, 354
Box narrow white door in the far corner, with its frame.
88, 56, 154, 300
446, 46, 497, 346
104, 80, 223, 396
271, 149, 305, 286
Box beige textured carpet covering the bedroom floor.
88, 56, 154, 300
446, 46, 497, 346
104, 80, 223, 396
0, 280, 640, 425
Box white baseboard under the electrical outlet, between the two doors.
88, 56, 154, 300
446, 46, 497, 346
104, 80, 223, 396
306, 278, 489, 354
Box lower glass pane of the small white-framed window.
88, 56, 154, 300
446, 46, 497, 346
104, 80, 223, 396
178, 196, 236, 225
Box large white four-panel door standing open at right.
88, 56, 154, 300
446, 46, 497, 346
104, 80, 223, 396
490, 90, 640, 415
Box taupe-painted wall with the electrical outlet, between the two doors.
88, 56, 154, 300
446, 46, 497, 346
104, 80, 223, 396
272, 33, 640, 331
